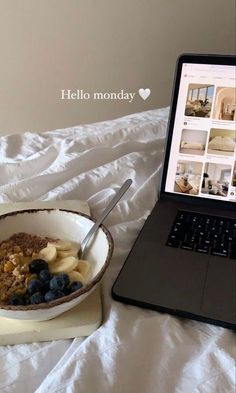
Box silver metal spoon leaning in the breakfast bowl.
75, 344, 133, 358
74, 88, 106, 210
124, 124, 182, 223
78, 179, 132, 259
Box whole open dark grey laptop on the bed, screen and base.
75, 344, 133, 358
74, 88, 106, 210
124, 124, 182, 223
112, 54, 236, 329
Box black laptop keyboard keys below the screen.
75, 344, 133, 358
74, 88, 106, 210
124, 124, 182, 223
166, 210, 236, 259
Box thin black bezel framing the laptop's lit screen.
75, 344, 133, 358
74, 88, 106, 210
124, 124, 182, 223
160, 54, 236, 210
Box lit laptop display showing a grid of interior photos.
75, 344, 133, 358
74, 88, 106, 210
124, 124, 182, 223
165, 63, 236, 202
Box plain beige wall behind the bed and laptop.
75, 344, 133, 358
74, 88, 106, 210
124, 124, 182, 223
0, 0, 235, 133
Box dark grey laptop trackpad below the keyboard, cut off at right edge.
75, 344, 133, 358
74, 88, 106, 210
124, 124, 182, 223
202, 257, 236, 323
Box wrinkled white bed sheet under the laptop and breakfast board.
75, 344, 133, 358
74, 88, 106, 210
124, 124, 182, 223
0, 108, 236, 393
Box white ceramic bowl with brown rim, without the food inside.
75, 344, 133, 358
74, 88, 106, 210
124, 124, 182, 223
0, 209, 113, 321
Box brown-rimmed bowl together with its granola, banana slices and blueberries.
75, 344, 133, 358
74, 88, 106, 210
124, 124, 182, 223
0, 209, 114, 321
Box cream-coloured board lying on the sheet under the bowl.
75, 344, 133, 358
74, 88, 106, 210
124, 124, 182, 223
0, 200, 102, 345
